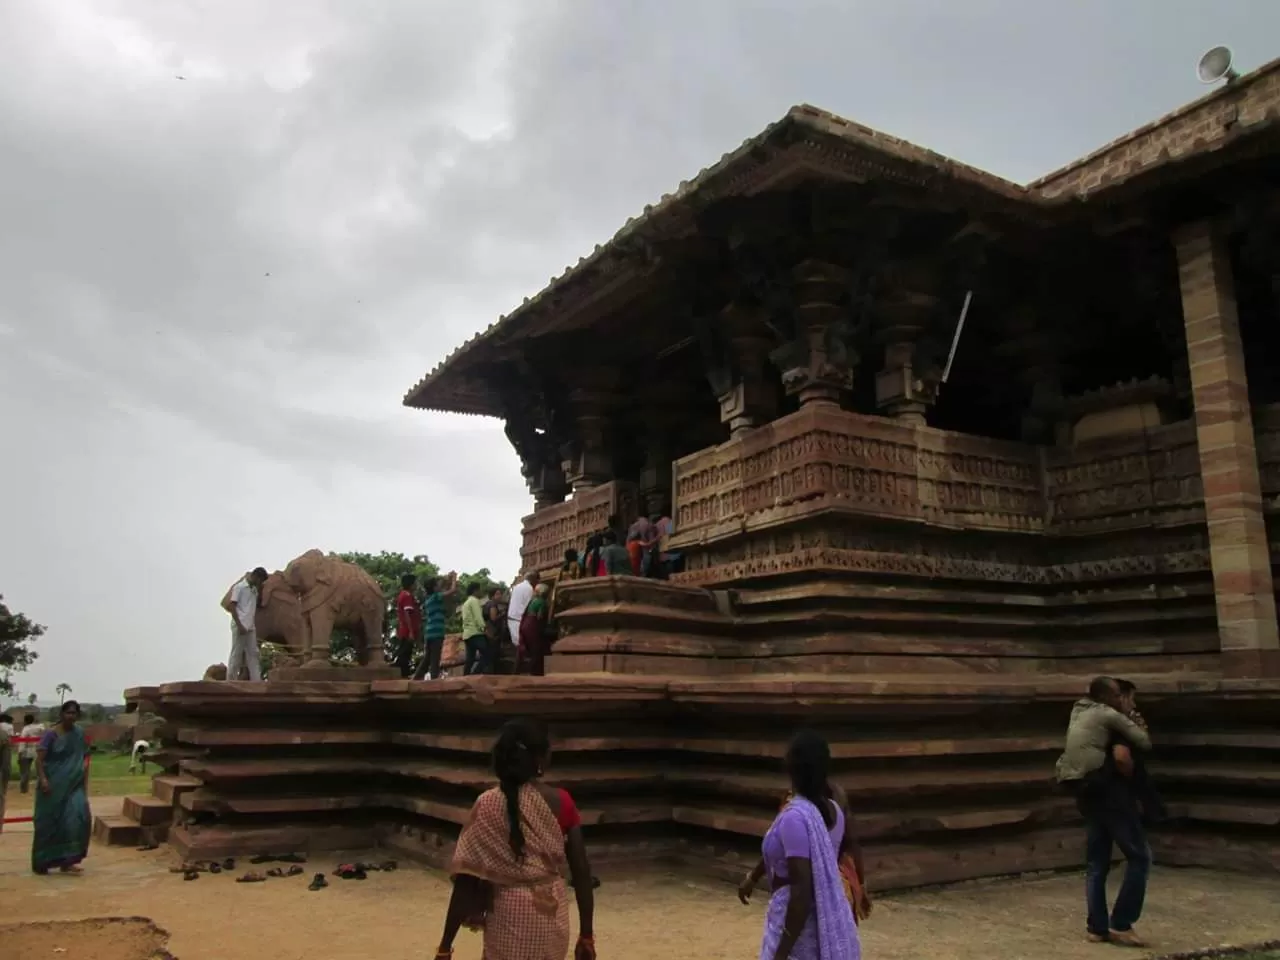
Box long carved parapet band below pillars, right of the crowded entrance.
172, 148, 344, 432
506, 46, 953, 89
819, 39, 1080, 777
675, 408, 1208, 563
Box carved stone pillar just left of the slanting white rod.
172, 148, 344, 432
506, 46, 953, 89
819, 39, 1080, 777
876, 289, 942, 426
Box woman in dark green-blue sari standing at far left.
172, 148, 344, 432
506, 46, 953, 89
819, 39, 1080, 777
31, 700, 92, 874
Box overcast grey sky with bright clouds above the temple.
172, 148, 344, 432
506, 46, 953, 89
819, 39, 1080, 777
0, 0, 1280, 700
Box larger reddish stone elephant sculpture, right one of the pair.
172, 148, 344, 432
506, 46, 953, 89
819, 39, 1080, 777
284, 550, 387, 664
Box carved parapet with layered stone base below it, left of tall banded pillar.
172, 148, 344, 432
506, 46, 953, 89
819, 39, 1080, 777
660, 408, 1219, 675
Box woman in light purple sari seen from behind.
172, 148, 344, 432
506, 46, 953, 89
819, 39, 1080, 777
760, 732, 860, 960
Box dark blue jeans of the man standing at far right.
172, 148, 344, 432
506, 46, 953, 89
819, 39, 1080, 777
1084, 809, 1151, 937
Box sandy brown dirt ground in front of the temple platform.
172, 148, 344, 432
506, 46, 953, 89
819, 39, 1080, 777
0, 828, 1280, 960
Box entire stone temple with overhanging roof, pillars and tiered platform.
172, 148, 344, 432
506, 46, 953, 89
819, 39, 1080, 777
112, 60, 1280, 888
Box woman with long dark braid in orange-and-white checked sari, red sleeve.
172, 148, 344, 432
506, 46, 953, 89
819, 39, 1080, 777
435, 719, 595, 960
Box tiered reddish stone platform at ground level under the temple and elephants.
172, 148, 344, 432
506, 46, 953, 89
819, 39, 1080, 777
127, 672, 1280, 890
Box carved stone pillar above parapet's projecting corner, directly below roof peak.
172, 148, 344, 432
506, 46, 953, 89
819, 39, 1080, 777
772, 260, 858, 407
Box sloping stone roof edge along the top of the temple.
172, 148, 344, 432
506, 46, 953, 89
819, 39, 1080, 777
404, 59, 1280, 415
